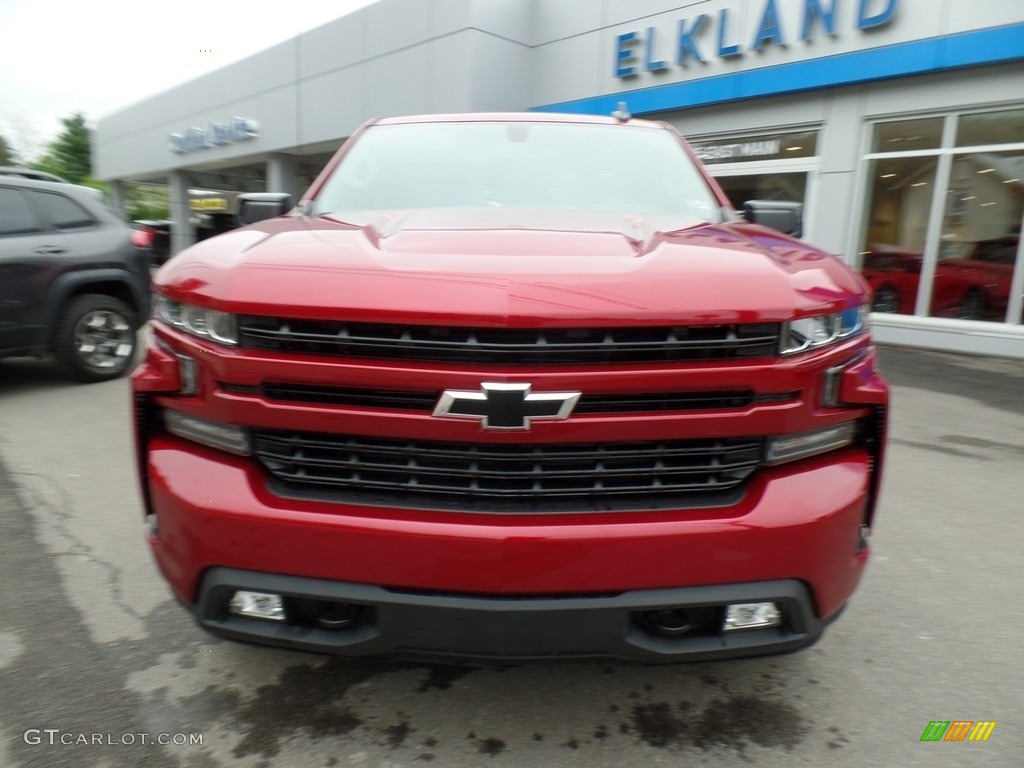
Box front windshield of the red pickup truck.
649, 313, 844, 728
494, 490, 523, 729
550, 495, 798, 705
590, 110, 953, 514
312, 122, 719, 223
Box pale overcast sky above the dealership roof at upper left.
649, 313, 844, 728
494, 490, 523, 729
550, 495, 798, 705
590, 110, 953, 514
0, 0, 374, 162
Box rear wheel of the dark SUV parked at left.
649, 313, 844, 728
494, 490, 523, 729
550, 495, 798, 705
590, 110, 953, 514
54, 294, 135, 381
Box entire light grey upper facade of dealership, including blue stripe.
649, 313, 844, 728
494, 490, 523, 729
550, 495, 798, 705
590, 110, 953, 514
96, 0, 1024, 181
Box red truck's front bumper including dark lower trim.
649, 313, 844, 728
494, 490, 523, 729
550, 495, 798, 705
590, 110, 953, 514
145, 435, 871, 663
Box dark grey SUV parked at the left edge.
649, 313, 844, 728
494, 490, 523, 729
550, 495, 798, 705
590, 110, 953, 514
0, 175, 150, 381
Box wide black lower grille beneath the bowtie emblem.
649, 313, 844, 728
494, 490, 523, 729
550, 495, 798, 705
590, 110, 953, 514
253, 430, 764, 511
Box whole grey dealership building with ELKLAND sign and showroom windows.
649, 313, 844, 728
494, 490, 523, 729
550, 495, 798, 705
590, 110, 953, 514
94, 0, 1024, 358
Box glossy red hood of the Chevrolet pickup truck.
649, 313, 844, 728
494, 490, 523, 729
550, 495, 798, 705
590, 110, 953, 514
155, 209, 866, 327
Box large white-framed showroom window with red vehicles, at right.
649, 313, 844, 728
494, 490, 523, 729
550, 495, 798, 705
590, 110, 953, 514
859, 110, 1024, 324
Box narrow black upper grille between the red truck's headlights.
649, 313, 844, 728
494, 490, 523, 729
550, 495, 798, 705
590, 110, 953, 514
239, 315, 779, 366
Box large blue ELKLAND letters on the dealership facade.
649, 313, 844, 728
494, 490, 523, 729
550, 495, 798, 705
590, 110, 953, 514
613, 0, 899, 79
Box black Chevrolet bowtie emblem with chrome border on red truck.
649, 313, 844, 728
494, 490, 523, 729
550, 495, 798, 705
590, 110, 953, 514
434, 382, 580, 429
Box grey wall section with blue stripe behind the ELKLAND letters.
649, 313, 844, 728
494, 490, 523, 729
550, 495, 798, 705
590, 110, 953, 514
534, 0, 1024, 114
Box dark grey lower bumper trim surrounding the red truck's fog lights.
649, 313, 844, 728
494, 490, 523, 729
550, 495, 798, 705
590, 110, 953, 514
185, 567, 827, 664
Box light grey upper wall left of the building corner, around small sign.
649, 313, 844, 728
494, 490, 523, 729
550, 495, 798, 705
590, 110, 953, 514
95, 0, 531, 179
